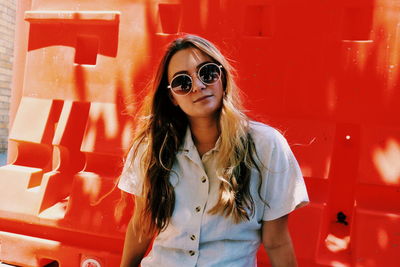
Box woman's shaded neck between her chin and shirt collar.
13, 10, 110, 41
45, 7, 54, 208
190, 118, 219, 155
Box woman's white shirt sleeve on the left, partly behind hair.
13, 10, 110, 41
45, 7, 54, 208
118, 143, 145, 196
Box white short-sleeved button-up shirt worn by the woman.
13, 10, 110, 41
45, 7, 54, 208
118, 122, 308, 267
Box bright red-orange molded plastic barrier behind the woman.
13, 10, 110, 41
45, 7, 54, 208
0, 0, 400, 267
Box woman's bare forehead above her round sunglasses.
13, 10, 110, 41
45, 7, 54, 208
168, 48, 212, 78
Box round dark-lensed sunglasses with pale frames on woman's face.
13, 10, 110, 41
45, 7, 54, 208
167, 62, 222, 95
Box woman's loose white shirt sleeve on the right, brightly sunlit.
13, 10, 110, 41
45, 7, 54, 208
263, 132, 309, 221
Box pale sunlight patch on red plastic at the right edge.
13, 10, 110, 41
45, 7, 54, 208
372, 138, 400, 185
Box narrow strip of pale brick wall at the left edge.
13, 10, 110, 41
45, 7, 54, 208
0, 0, 16, 153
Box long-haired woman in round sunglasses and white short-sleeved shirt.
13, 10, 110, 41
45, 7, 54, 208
118, 35, 308, 267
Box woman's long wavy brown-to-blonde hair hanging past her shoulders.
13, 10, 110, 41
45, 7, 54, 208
122, 35, 259, 238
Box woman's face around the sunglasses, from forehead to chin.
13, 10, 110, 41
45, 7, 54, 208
168, 48, 224, 119
